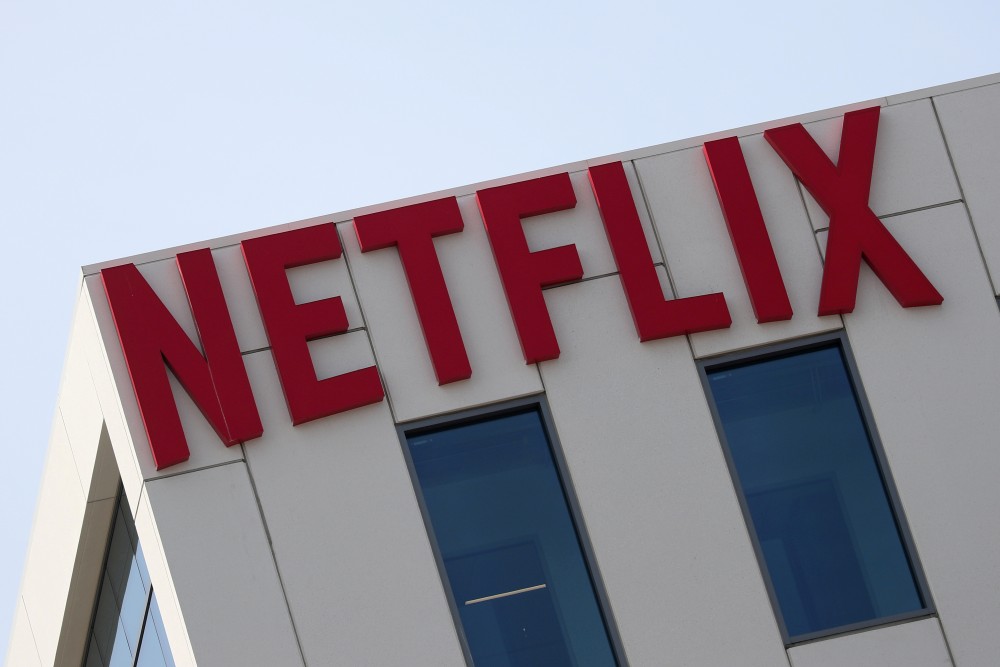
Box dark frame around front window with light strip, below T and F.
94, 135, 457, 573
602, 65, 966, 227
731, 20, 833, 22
396, 394, 629, 667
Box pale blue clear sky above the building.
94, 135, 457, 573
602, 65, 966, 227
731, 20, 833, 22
0, 0, 1000, 656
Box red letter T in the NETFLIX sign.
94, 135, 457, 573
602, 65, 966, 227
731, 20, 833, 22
354, 197, 472, 384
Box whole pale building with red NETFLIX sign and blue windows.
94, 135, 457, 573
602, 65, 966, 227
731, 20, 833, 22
7, 76, 1000, 667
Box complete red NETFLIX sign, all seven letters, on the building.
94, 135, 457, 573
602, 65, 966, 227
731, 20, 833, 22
101, 107, 942, 469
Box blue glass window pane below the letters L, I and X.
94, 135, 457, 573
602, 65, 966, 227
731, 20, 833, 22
707, 345, 926, 640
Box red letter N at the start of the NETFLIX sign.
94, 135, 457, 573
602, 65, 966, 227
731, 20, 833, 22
101, 249, 264, 470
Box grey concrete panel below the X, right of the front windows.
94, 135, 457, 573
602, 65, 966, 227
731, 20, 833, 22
828, 204, 1000, 665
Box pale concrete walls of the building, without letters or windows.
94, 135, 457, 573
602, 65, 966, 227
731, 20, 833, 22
8, 77, 1000, 667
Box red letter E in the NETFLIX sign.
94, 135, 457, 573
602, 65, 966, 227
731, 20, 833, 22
241, 224, 385, 425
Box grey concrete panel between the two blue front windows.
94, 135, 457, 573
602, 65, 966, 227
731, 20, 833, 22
541, 276, 786, 667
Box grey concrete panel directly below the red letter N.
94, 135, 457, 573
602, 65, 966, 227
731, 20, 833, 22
140, 461, 303, 665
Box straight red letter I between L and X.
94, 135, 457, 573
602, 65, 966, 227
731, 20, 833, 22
704, 137, 792, 324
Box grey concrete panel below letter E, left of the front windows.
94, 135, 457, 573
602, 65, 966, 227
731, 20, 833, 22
242, 352, 465, 667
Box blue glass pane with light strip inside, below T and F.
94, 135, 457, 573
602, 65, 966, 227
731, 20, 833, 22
407, 410, 616, 667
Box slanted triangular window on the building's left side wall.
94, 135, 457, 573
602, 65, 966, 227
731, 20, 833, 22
84, 493, 174, 667
